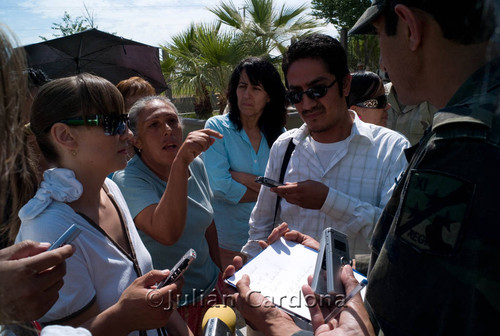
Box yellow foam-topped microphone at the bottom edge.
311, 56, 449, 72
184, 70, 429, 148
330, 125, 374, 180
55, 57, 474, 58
201, 305, 236, 336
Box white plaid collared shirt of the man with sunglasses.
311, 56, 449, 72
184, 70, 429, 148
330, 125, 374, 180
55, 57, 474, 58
242, 111, 409, 257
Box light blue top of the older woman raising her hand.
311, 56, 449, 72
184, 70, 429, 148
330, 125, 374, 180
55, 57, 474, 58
113, 155, 219, 306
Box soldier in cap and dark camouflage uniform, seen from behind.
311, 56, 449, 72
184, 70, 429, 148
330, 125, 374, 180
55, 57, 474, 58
350, 0, 500, 335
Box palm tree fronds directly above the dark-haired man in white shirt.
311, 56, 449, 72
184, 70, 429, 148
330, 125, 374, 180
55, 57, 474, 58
209, 0, 318, 62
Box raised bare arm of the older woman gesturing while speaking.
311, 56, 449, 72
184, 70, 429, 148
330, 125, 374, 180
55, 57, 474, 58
134, 129, 222, 245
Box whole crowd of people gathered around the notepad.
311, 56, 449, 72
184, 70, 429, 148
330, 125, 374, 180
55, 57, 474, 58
0, 0, 500, 336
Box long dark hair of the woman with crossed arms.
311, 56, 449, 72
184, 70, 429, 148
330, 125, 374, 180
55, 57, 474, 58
227, 57, 287, 147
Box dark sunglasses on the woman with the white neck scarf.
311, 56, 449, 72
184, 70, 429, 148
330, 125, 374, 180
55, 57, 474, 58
58, 114, 128, 135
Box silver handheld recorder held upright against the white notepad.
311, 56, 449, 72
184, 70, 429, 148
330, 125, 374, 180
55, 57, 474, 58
311, 228, 351, 297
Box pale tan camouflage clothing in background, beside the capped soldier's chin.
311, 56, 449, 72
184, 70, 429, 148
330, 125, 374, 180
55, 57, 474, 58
384, 83, 437, 146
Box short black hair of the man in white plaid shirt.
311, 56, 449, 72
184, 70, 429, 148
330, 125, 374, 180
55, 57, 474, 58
281, 34, 349, 96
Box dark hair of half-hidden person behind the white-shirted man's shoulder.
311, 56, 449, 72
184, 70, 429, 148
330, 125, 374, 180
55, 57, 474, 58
347, 71, 384, 106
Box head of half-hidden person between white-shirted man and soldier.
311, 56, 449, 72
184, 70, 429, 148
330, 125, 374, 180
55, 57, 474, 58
347, 71, 391, 127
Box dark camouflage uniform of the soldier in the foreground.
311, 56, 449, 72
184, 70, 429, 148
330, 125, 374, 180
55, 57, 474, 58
366, 59, 500, 335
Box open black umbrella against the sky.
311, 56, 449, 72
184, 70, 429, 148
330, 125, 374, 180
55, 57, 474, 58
24, 29, 167, 93
